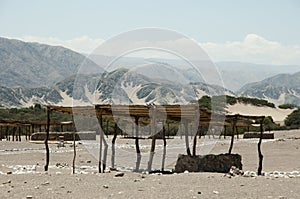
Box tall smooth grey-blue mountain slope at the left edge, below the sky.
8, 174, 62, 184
0, 37, 99, 88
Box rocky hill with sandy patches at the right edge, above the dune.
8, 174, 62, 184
238, 72, 300, 106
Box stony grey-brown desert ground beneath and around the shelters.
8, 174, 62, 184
0, 130, 300, 199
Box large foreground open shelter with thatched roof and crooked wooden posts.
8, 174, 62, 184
45, 104, 265, 175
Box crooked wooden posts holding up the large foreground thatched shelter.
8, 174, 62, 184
44, 107, 263, 175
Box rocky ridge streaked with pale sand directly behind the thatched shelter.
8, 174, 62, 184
0, 69, 233, 107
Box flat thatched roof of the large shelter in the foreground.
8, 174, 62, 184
47, 104, 265, 127
